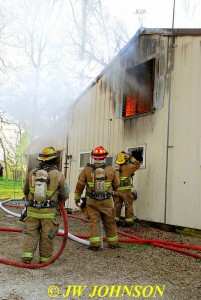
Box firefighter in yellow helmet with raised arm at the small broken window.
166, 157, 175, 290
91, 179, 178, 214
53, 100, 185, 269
113, 151, 140, 227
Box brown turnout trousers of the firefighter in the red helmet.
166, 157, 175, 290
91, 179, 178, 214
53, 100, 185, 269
87, 198, 118, 246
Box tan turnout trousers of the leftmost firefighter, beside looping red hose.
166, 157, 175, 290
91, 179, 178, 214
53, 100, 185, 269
21, 217, 59, 261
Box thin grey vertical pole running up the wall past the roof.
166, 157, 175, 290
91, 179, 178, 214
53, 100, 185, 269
164, 0, 176, 224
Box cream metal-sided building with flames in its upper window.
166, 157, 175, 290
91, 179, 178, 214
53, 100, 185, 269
30, 28, 201, 229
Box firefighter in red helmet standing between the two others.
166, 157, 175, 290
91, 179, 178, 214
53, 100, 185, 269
74, 146, 120, 251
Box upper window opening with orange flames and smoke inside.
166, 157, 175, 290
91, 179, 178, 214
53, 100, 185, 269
123, 59, 154, 118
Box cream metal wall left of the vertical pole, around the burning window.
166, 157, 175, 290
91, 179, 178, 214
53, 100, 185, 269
68, 29, 168, 222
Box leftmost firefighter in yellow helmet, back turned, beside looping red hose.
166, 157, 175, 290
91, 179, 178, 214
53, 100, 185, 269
20, 147, 69, 264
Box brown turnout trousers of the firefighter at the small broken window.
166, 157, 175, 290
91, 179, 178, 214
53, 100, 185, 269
114, 190, 134, 222
